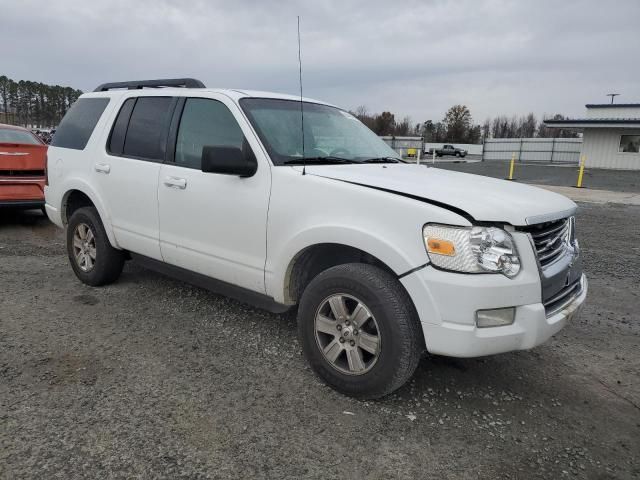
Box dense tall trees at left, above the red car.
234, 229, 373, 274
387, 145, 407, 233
0, 75, 82, 128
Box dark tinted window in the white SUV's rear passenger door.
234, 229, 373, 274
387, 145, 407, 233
121, 97, 174, 161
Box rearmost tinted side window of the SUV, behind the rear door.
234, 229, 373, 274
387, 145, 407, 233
51, 98, 109, 150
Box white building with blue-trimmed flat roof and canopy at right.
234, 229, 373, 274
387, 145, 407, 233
544, 103, 640, 170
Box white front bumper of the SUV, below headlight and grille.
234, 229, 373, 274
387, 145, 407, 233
401, 250, 588, 357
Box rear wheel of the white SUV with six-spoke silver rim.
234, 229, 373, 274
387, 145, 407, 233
67, 207, 125, 287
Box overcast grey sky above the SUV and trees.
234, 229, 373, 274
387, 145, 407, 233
0, 0, 640, 122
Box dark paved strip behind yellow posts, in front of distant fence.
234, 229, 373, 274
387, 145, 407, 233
427, 161, 640, 193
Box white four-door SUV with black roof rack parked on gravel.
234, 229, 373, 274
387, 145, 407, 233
46, 79, 587, 398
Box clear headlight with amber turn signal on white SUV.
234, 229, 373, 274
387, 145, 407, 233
422, 224, 520, 277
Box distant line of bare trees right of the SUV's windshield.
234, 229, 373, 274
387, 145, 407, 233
352, 105, 578, 143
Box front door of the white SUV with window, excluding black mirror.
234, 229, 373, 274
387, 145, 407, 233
158, 95, 271, 293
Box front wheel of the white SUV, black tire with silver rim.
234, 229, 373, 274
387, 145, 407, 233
298, 263, 425, 399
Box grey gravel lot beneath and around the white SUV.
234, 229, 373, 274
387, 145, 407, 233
0, 205, 640, 479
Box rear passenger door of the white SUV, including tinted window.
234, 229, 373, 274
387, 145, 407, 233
92, 96, 177, 260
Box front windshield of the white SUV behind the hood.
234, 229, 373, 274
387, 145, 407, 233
240, 98, 401, 165
